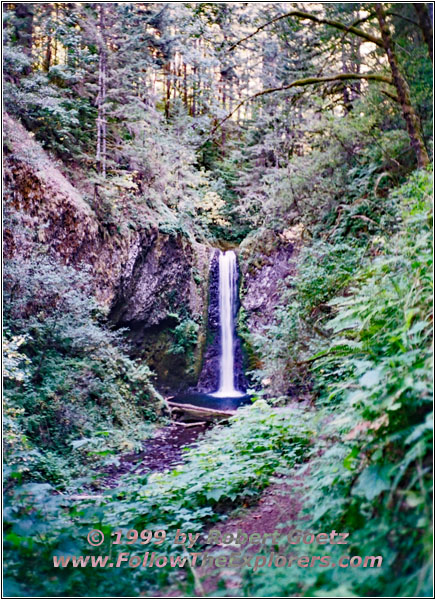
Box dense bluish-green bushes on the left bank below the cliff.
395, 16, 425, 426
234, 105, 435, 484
4, 256, 164, 489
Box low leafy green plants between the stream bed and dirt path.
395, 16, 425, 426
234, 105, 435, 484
5, 400, 313, 597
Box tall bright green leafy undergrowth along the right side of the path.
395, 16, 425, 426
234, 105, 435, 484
237, 171, 433, 597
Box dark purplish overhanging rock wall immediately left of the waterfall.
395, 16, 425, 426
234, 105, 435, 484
110, 230, 211, 392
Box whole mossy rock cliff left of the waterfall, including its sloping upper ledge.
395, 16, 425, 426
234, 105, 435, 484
4, 115, 211, 392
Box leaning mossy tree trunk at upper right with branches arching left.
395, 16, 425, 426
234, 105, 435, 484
375, 2, 429, 168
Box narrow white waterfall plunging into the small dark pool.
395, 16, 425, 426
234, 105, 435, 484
213, 250, 244, 398
